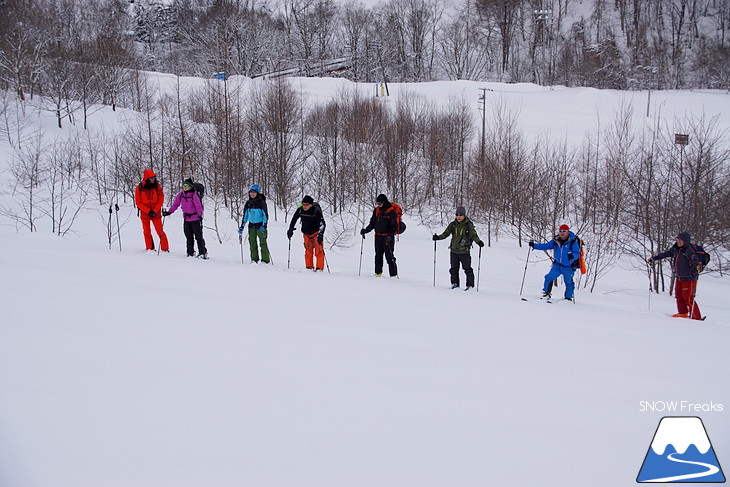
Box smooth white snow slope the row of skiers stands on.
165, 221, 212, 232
0, 79, 730, 487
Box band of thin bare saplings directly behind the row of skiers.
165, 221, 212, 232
0, 70, 730, 290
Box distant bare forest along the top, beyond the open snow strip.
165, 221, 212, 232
0, 0, 730, 101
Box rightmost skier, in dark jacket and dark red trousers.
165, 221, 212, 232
646, 232, 702, 320
